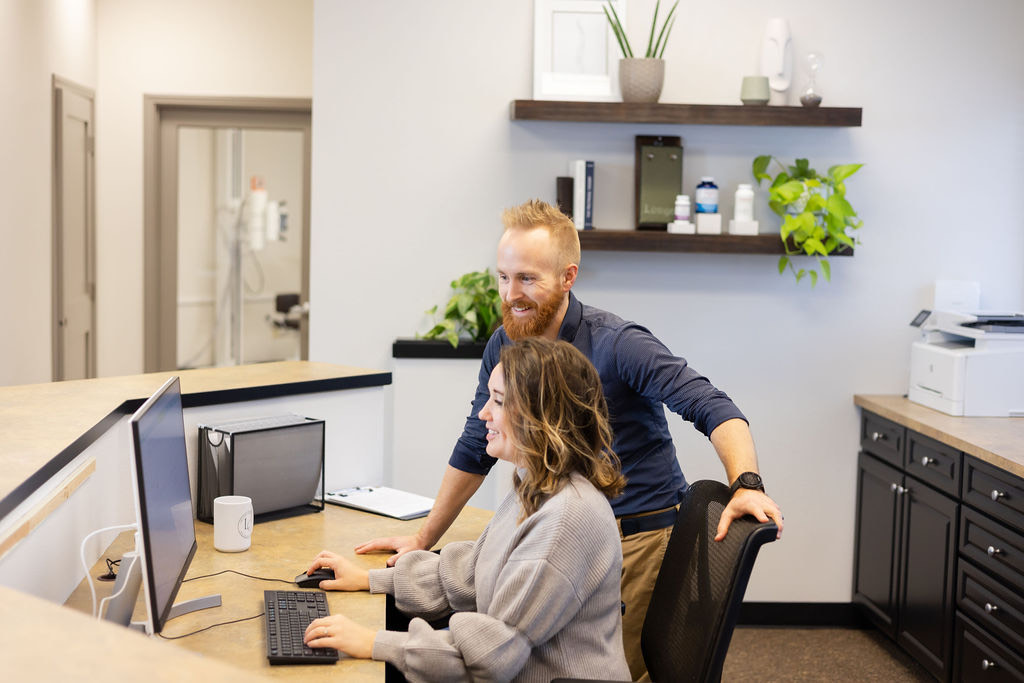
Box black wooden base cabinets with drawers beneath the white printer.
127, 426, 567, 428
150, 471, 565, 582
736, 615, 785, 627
853, 411, 1024, 683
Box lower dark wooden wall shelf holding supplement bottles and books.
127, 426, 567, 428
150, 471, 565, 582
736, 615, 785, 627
580, 229, 853, 256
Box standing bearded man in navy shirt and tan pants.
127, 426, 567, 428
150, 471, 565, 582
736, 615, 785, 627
355, 200, 782, 680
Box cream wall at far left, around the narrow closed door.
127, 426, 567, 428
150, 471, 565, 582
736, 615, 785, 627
0, 0, 96, 385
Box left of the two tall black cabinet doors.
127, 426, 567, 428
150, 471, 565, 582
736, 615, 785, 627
853, 453, 903, 637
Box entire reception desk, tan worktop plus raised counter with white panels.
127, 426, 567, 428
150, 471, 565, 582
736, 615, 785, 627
0, 361, 490, 680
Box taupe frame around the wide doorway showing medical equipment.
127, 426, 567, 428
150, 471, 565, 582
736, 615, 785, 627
142, 95, 312, 373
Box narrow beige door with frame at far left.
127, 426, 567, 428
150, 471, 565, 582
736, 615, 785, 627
51, 75, 96, 381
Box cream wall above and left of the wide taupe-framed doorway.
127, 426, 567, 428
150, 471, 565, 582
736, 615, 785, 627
96, 0, 312, 376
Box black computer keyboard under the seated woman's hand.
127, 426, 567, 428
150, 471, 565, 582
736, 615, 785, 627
263, 591, 338, 664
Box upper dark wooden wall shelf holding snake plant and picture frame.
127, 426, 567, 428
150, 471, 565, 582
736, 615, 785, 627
512, 99, 861, 127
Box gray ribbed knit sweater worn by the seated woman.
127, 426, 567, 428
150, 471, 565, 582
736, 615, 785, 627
370, 474, 630, 683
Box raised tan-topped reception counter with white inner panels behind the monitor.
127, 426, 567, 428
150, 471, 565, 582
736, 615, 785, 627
0, 361, 391, 603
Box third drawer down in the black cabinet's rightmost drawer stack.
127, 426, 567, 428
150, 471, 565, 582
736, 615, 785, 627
956, 562, 1024, 652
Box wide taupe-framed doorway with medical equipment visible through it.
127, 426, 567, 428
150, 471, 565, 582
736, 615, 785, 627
143, 96, 311, 372
